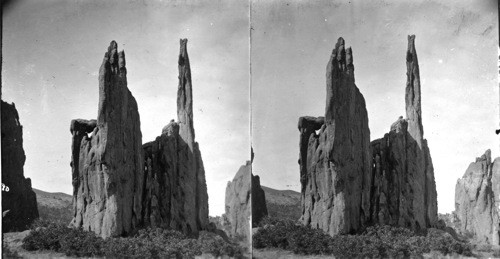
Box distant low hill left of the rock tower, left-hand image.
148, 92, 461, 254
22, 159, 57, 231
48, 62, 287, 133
33, 188, 73, 225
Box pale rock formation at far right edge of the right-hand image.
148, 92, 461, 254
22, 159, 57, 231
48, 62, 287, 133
455, 150, 500, 246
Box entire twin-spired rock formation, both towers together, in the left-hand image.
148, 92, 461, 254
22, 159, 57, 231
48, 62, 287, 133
70, 39, 208, 237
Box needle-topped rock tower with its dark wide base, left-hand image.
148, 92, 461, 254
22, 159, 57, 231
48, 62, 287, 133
142, 39, 208, 235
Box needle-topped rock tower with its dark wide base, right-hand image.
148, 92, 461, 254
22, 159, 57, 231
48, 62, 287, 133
368, 35, 437, 230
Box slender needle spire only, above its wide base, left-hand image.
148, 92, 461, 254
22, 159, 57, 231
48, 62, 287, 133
177, 39, 195, 150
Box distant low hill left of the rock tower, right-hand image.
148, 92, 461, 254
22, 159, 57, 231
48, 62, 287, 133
262, 186, 302, 220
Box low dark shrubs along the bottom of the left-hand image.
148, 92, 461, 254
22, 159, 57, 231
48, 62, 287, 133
23, 224, 243, 258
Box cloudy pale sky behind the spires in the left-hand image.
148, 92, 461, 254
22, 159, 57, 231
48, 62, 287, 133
2, 0, 250, 215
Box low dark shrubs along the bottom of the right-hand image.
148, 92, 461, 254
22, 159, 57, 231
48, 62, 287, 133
253, 219, 472, 258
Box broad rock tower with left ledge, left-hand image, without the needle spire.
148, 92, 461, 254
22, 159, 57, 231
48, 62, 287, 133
70, 41, 144, 238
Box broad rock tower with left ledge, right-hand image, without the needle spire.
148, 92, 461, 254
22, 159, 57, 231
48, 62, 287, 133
298, 38, 371, 235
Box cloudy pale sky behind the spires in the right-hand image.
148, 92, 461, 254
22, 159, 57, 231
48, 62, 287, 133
254, 0, 499, 213
